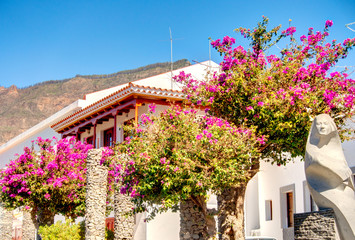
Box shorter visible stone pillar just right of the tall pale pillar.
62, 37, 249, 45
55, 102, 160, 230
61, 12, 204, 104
114, 188, 135, 240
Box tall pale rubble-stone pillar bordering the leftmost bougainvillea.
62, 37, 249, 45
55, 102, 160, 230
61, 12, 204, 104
85, 149, 107, 240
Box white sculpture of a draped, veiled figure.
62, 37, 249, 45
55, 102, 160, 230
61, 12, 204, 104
305, 114, 355, 240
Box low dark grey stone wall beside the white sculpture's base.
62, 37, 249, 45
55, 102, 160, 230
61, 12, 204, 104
294, 209, 338, 240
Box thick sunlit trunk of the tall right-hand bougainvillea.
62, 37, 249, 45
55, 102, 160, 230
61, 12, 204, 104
217, 183, 247, 240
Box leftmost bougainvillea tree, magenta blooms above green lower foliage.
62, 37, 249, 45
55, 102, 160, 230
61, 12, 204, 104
0, 138, 113, 227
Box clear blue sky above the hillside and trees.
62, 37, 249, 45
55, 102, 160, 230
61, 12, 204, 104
0, 0, 355, 87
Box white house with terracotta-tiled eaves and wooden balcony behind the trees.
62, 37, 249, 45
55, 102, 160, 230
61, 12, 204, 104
0, 61, 355, 240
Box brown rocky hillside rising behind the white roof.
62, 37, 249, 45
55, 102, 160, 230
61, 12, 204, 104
0, 59, 190, 145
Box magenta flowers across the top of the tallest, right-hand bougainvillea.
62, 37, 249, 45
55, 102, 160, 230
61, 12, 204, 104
176, 20, 355, 112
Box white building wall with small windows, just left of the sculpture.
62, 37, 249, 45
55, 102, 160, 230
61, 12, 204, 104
245, 126, 355, 240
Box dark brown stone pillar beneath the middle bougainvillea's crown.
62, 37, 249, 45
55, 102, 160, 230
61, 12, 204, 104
180, 199, 209, 240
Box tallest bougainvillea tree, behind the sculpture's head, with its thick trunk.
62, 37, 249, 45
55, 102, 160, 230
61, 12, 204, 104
176, 17, 355, 239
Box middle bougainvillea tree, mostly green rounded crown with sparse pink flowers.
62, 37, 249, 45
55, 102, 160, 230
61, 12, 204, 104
109, 106, 264, 236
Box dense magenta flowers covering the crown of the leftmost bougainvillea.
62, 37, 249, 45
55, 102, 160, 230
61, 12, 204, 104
0, 138, 92, 212
